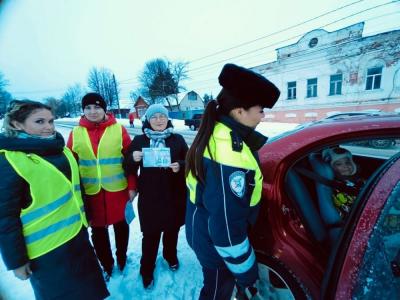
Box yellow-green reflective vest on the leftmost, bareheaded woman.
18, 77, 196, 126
0, 148, 87, 259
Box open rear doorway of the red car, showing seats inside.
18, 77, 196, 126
286, 137, 400, 248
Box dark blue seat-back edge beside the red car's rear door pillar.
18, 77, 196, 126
286, 168, 327, 243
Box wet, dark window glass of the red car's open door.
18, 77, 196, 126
353, 182, 400, 299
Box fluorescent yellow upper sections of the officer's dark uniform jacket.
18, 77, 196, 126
186, 122, 263, 206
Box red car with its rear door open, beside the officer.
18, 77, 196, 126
250, 115, 400, 299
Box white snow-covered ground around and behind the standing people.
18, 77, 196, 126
0, 119, 297, 300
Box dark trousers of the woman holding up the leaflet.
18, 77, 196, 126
140, 228, 179, 277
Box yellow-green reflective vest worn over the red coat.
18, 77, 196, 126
72, 124, 128, 195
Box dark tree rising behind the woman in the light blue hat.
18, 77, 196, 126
139, 58, 187, 110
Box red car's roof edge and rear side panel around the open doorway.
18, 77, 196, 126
257, 115, 400, 299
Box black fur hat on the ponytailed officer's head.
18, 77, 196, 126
218, 64, 280, 109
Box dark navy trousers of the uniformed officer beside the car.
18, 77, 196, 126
199, 267, 235, 300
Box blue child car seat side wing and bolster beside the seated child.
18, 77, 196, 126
309, 153, 343, 245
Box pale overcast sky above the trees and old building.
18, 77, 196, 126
0, 0, 400, 100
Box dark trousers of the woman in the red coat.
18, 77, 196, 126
92, 220, 129, 274
